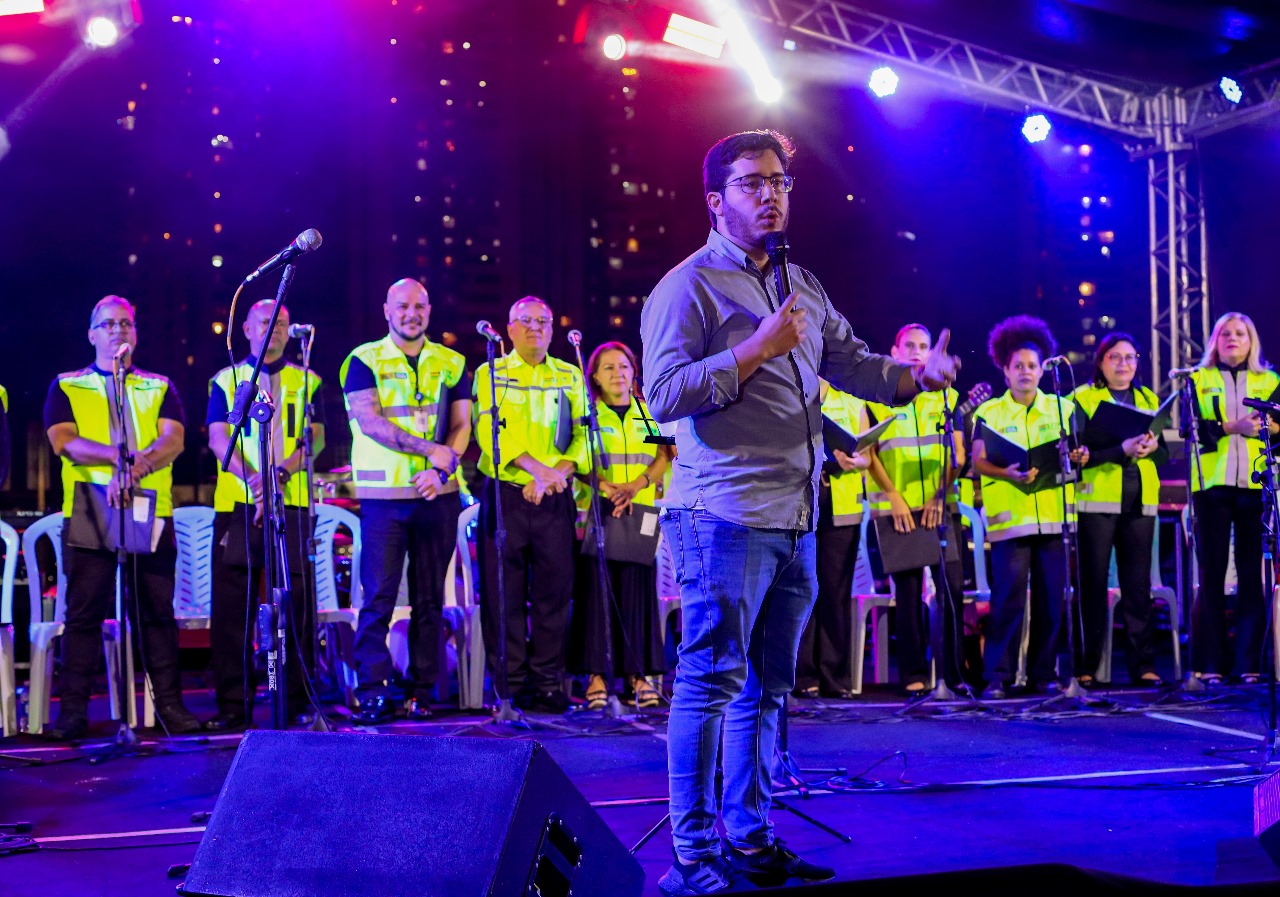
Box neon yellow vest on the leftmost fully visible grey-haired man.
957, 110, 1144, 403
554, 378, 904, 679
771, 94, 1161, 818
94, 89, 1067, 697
58, 367, 173, 517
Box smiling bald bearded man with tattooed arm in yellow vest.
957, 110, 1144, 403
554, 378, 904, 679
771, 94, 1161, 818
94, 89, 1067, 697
338, 278, 471, 726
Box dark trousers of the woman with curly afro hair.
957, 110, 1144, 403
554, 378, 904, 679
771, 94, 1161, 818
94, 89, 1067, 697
982, 534, 1069, 683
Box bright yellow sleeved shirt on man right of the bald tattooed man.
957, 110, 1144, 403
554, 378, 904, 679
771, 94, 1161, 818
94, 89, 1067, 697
471, 351, 590, 486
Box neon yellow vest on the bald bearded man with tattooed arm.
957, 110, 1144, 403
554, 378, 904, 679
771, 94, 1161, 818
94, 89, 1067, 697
339, 334, 466, 499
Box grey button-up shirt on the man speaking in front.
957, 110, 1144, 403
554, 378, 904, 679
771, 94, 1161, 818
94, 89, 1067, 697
640, 230, 915, 532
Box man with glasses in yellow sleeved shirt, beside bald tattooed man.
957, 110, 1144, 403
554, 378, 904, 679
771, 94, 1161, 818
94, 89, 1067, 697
474, 296, 588, 713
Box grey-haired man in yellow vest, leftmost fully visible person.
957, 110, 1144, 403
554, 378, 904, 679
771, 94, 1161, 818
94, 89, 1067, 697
45, 296, 200, 741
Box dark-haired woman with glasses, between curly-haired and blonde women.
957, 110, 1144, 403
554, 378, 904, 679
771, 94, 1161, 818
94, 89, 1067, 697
1073, 333, 1161, 687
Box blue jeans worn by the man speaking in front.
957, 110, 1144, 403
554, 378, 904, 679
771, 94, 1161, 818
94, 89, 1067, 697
662, 509, 818, 861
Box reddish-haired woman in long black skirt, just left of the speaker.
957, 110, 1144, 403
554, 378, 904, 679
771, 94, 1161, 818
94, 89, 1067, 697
570, 342, 671, 710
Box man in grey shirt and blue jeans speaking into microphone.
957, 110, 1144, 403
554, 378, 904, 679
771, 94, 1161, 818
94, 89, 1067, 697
640, 131, 957, 896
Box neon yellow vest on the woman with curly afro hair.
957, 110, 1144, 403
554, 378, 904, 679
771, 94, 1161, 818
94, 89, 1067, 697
974, 390, 1075, 541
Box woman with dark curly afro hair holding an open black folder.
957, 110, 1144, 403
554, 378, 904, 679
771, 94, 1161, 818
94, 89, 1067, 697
973, 315, 1088, 700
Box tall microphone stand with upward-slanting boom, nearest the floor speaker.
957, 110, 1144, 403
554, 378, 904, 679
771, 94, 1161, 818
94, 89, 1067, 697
221, 264, 296, 729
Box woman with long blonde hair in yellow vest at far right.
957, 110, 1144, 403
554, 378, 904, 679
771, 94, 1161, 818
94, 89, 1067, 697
1190, 311, 1280, 685
